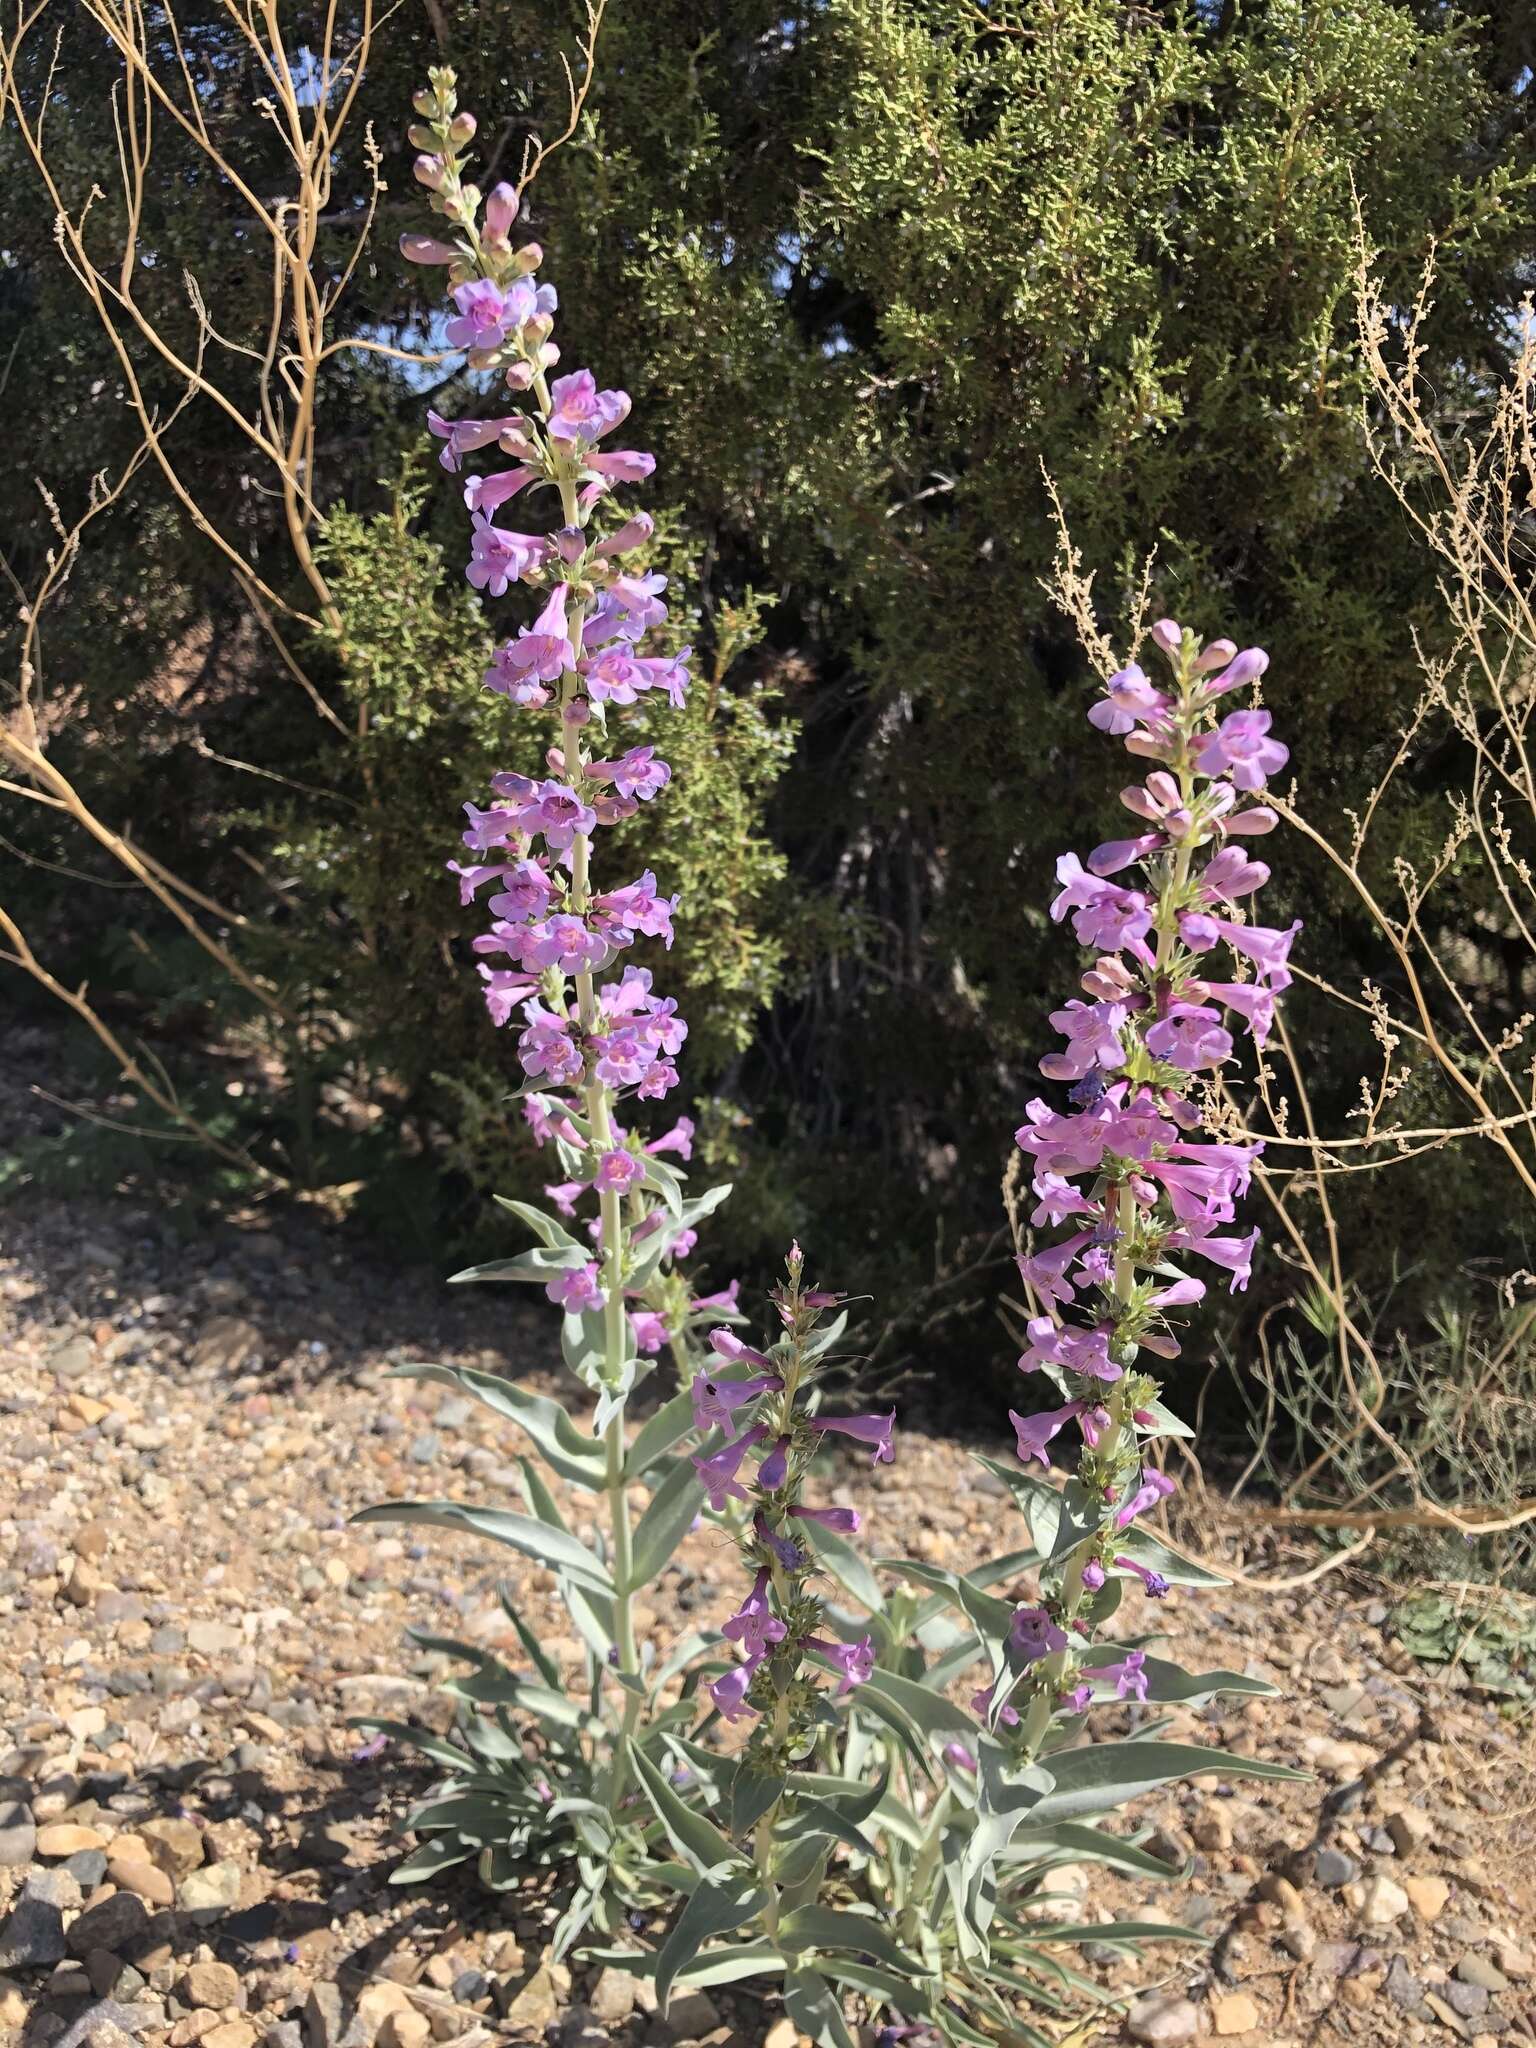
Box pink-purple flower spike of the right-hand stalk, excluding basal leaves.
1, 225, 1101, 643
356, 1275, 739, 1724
975, 618, 1300, 1759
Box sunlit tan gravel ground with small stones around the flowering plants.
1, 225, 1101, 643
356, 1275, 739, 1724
0, 1198, 1536, 2048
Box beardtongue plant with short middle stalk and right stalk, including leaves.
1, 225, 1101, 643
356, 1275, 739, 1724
577, 621, 1298, 2044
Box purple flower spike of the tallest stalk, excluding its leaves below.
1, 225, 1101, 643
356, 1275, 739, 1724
401, 70, 720, 1384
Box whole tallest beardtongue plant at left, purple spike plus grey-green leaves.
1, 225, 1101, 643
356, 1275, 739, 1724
360, 70, 753, 1950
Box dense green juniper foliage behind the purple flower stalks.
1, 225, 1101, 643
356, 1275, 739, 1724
0, 0, 1536, 1359
